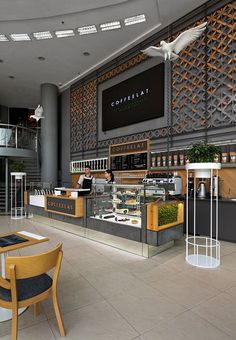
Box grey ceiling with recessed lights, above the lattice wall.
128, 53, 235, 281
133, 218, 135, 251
0, 0, 206, 108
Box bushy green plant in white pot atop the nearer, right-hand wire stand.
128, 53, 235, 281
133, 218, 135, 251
187, 142, 221, 178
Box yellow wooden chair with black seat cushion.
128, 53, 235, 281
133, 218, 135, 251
0, 244, 65, 340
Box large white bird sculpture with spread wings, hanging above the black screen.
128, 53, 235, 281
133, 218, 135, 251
141, 22, 207, 61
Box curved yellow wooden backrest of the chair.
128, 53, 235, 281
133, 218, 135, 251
6, 244, 62, 279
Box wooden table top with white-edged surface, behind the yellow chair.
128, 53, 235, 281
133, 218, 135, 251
0, 230, 49, 254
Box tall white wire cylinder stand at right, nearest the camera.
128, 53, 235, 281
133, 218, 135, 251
185, 163, 221, 268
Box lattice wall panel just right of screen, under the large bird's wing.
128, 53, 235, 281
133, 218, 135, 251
172, 21, 206, 134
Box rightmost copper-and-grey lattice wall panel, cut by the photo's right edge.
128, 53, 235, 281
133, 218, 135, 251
207, 1, 236, 128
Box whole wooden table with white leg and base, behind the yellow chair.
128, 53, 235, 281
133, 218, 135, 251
0, 231, 49, 322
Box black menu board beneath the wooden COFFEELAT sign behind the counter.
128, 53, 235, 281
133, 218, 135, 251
110, 152, 148, 171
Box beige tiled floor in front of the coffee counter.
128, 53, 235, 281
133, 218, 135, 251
0, 217, 236, 340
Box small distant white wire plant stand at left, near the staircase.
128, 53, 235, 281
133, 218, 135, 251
10, 172, 26, 220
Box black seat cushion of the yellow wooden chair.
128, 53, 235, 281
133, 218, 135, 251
0, 274, 52, 301
